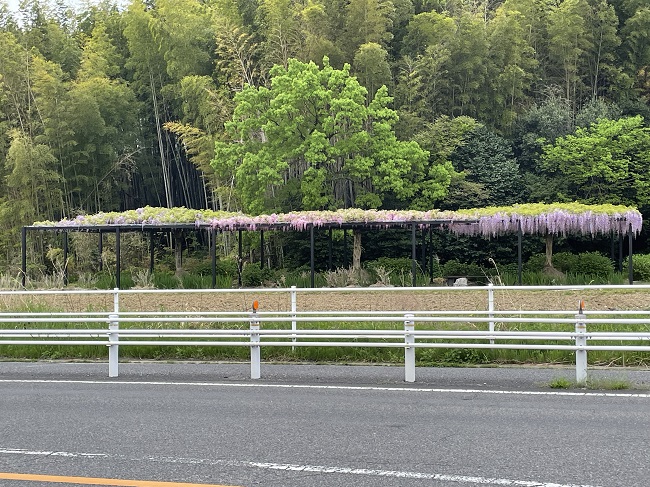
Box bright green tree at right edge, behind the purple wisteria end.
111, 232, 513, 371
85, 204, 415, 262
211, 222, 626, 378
542, 116, 650, 212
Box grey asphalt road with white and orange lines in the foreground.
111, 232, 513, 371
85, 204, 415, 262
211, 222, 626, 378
0, 362, 650, 487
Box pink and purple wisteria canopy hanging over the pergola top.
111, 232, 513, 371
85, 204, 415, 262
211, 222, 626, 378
34, 203, 642, 237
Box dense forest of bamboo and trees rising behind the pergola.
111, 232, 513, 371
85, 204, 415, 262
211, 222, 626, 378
0, 0, 650, 274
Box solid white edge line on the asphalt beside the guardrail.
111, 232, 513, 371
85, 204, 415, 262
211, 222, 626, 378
0, 379, 650, 399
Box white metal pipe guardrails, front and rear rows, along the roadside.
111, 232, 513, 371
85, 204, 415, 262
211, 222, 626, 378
0, 285, 650, 383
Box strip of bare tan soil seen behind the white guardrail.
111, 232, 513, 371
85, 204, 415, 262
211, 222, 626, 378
5, 288, 650, 312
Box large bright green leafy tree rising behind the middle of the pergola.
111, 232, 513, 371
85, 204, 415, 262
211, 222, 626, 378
213, 58, 431, 213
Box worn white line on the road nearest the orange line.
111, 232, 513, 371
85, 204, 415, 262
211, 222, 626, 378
0, 448, 597, 487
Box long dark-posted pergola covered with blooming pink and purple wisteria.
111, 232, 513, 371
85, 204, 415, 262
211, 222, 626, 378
21, 203, 642, 287
